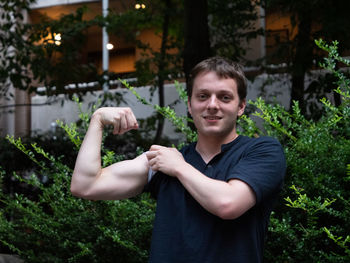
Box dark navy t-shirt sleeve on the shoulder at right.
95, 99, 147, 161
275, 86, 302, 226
227, 137, 286, 204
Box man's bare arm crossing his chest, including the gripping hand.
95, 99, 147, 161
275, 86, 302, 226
147, 145, 256, 219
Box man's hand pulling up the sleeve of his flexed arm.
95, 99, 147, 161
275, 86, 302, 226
146, 145, 187, 177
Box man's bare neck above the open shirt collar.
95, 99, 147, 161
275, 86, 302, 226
196, 133, 238, 163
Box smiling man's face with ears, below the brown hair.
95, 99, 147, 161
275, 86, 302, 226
188, 72, 246, 142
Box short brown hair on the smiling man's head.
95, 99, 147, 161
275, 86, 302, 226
187, 57, 247, 101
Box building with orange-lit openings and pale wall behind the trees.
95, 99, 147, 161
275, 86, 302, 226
0, 0, 290, 138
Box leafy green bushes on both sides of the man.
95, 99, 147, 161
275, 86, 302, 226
0, 38, 350, 262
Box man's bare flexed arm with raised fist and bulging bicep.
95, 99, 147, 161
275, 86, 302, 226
71, 107, 149, 200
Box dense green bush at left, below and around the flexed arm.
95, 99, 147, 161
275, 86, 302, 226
0, 100, 154, 262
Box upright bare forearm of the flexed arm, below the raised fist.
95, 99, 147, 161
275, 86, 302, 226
71, 114, 103, 195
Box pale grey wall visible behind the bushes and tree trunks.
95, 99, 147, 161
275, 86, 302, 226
31, 74, 290, 140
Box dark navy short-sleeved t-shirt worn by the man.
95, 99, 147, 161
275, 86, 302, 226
145, 136, 286, 263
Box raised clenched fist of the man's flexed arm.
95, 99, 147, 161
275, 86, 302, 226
92, 107, 139, 134
